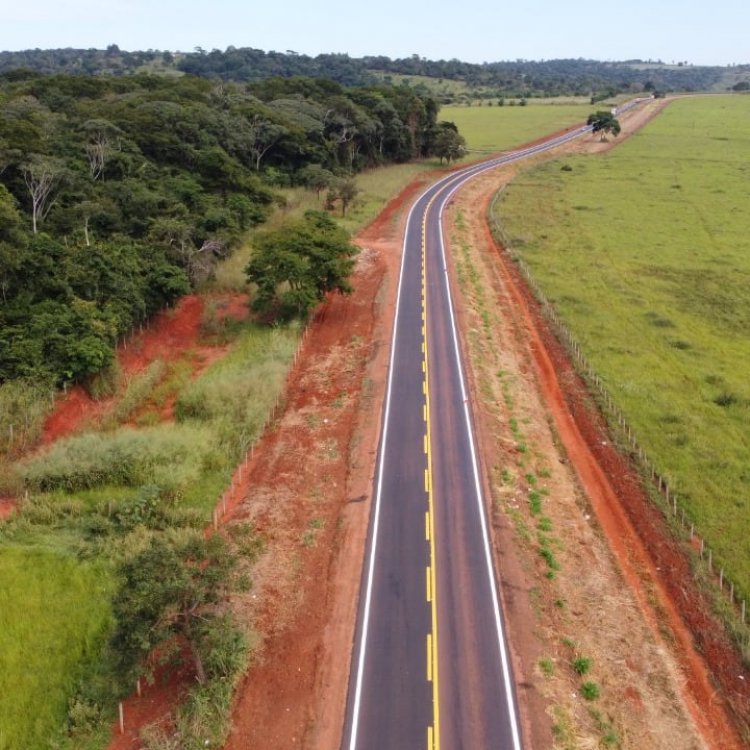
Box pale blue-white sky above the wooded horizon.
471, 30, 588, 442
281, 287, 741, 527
0, 0, 750, 65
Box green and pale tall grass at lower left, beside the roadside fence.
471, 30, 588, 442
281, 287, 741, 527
0, 322, 298, 750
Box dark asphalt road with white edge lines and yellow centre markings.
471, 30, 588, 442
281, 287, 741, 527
342, 107, 648, 750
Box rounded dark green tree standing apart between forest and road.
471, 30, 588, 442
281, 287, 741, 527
246, 211, 359, 318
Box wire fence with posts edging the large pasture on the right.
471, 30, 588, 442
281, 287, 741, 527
503, 250, 750, 648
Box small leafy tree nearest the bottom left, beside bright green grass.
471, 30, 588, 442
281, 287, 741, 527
112, 531, 246, 684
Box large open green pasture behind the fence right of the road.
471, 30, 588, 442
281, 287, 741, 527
496, 96, 750, 598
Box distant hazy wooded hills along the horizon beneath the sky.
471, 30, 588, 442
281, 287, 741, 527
0, 45, 750, 101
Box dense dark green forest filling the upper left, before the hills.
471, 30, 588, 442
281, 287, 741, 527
0, 72, 440, 383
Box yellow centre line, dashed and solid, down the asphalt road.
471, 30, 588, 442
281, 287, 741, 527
422, 207, 440, 750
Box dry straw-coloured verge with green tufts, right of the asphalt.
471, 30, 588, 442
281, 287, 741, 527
450, 209, 642, 748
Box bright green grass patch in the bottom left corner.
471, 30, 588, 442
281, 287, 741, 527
0, 546, 110, 750
